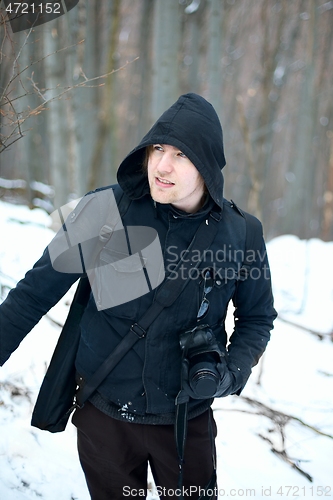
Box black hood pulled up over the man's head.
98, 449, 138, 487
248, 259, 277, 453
117, 94, 225, 207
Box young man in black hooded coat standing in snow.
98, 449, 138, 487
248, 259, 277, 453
0, 94, 276, 500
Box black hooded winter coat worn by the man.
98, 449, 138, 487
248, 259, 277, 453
0, 94, 276, 421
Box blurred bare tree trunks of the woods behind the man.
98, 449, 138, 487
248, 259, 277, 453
0, 0, 333, 240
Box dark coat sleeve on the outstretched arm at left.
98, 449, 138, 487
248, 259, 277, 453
0, 188, 121, 365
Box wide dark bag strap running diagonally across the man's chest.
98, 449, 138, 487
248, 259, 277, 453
75, 207, 222, 408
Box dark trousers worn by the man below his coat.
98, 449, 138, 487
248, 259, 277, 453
72, 403, 216, 500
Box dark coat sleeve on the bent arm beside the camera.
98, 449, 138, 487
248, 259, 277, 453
228, 236, 277, 394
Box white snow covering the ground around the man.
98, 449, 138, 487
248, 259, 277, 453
0, 202, 333, 500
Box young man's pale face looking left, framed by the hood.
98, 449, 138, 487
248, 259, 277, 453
148, 144, 205, 213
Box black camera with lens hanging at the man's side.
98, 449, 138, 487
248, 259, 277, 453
179, 325, 225, 398
